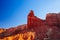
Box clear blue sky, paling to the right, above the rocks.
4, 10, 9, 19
0, 0, 60, 28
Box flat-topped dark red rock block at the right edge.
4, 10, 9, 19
46, 13, 60, 27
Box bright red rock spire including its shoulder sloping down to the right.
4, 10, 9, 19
27, 10, 44, 28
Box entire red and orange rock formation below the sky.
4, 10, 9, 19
0, 10, 60, 40
